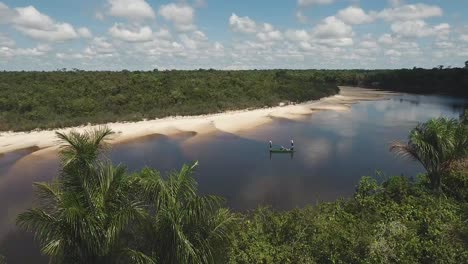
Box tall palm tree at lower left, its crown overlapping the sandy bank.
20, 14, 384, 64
17, 128, 153, 263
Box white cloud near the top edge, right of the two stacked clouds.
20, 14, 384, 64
159, 3, 196, 31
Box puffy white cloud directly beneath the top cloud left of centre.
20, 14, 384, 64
109, 23, 153, 42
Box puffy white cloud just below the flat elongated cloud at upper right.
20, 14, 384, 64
391, 20, 450, 38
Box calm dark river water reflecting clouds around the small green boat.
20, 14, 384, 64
0, 92, 468, 263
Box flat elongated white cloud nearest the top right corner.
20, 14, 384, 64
377, 4, 443, 21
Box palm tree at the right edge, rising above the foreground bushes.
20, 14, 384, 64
390, 118, 468, 190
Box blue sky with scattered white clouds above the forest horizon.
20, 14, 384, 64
0, 0, 468, 70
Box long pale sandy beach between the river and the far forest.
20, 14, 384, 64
0, 87, 392, 154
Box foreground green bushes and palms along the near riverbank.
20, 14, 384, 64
6, 112, 468, 263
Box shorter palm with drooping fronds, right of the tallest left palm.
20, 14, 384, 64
139, 163, 236, 263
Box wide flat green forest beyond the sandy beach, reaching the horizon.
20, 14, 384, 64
0, 68, 468, 131
